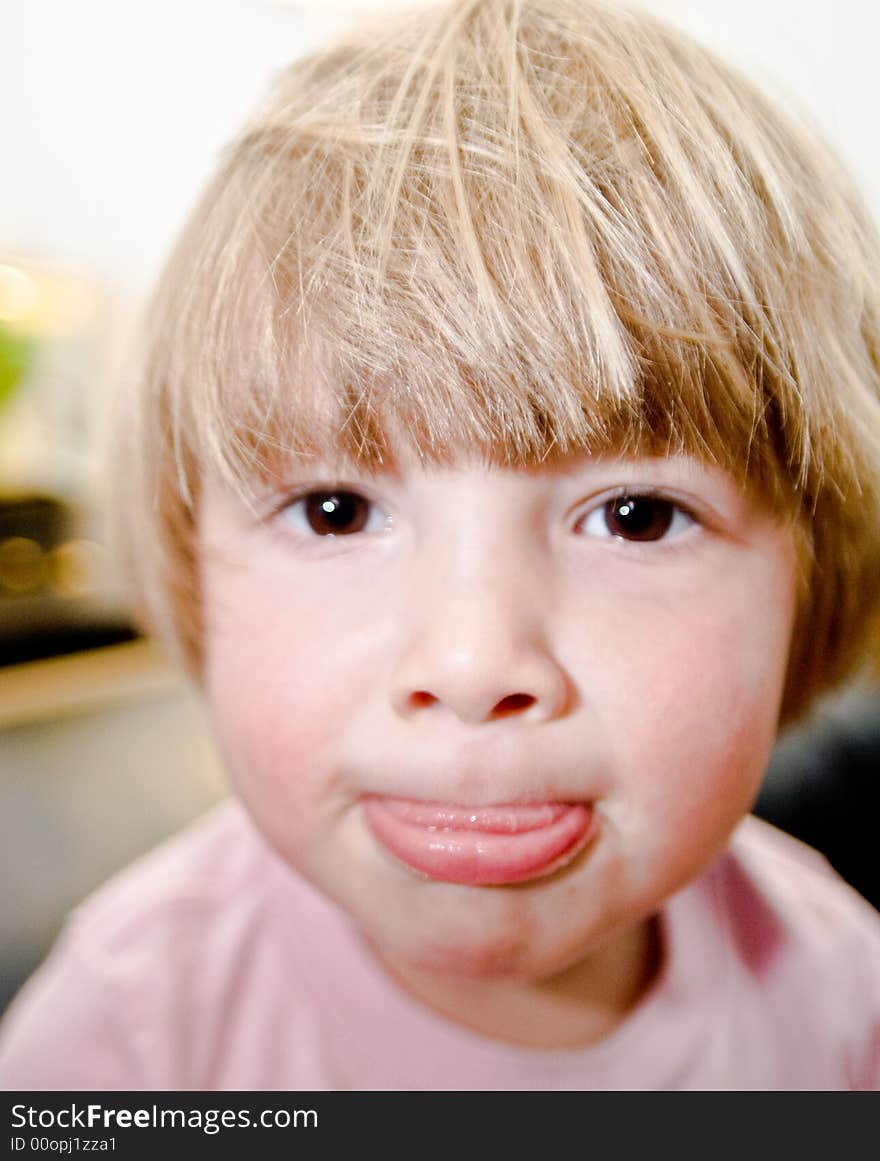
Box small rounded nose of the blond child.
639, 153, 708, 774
391, 552, 570, 724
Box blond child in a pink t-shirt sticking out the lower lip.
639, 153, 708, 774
0, 0, 880, 1090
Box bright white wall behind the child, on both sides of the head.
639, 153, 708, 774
0, 0, 880, 295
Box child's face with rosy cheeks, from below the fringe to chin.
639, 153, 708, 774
201, 457, 795, 981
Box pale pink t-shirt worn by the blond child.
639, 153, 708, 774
0, 802, 880, 1090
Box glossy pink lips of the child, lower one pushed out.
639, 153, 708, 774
363, 798, 596, 887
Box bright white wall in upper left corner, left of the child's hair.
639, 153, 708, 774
0, 0, 329, 291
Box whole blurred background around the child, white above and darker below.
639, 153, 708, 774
0, 0, 880, 1010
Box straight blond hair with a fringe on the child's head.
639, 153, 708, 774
120, 0, 880, 717
